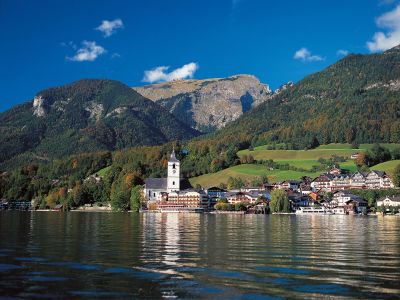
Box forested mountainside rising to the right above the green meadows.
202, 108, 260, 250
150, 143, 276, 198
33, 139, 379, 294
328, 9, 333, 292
206, 47, 400, 148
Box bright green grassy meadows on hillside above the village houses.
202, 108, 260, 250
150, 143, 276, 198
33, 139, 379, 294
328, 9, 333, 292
190, 144, 399, 187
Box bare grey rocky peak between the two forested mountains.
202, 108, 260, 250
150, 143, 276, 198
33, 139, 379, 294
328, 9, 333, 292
134, 75, 273, 132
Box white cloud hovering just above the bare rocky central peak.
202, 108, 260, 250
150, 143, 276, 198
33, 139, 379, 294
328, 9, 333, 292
143, 62, 199, 83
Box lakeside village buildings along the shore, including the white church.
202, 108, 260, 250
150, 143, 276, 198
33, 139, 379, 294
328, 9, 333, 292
143, 151, 400, 214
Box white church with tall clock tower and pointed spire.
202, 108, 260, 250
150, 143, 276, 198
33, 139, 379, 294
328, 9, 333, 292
143, 150, 181, 201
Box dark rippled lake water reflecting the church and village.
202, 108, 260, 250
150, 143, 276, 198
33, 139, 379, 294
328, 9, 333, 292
0, 212, 400, 299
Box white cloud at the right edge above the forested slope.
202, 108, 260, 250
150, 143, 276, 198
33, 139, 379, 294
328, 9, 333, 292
367, 5, 400, 52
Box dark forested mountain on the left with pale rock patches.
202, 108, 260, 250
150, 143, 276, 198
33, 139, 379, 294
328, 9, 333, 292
0, 79, 199, 166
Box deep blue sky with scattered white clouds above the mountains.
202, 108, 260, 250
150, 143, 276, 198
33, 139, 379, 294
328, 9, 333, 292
0, 0, 400, 111
